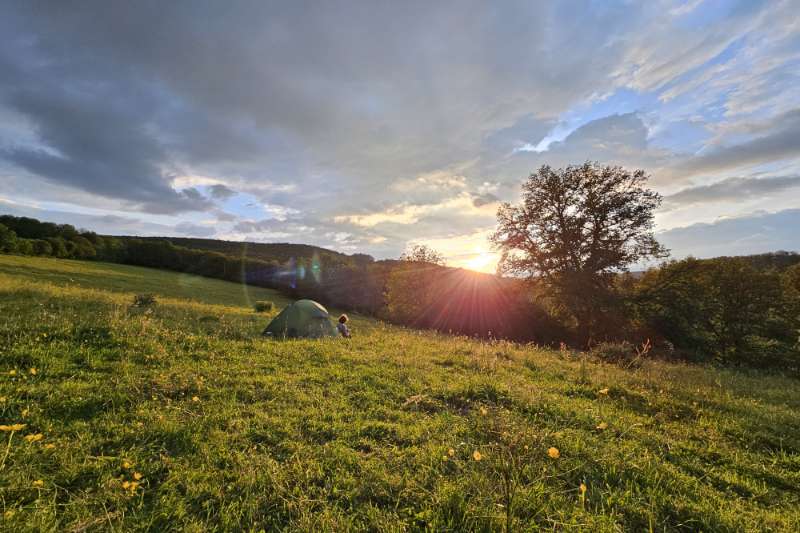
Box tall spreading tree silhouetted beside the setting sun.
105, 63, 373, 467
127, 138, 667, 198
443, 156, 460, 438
491, 162, 668, 338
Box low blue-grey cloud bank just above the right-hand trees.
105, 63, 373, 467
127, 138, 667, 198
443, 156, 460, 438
657, 209, 800, 258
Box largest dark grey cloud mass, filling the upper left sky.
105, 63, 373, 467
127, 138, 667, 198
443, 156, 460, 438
0, 1, 633, 212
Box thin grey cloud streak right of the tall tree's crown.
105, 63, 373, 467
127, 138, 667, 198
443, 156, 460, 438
664, 176, 800, 208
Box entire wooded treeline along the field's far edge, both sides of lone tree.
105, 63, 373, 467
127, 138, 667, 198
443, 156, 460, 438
0, 216, 800, 371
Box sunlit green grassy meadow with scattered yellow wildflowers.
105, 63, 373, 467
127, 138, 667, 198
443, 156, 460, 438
0, 256, 800, 531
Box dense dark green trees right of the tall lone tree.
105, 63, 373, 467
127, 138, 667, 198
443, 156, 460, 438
618, 258, 800, 371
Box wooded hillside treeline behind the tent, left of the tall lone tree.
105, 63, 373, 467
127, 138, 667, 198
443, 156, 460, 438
0, 216, 567, 344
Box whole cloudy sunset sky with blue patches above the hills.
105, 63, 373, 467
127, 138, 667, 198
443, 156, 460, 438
0, 0, 800, 271
